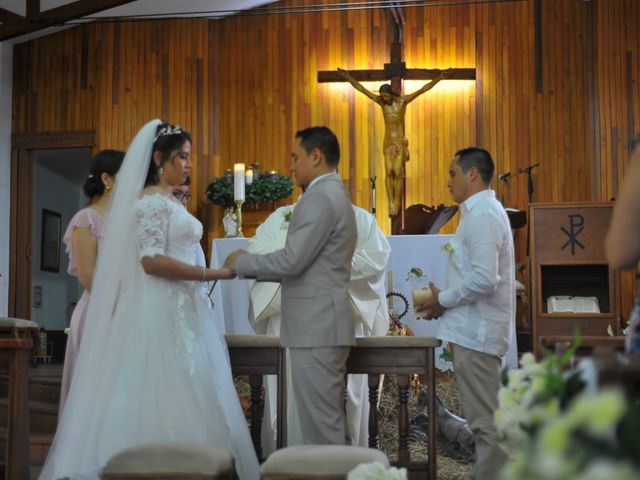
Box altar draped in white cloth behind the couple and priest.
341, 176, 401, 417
211, 235, 452, 337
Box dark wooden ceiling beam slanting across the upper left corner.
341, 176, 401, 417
0, 0, 134, 42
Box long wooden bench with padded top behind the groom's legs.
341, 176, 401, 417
225, 335, 441, 479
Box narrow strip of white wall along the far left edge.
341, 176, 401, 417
0, 42, 13, 316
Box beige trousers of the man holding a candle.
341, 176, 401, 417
451, 344, 507, 480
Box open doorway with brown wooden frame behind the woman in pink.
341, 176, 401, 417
9, 131, 96, 344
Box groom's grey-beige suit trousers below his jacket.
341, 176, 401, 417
289, 347, 350, 445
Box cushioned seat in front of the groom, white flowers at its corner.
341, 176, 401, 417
260, 445, 389, 480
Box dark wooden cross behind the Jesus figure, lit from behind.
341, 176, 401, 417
318, 7, 476, 234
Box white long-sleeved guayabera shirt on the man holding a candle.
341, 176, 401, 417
437, 190, 516, 357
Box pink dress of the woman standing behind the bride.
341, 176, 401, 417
60, 207, 105, 412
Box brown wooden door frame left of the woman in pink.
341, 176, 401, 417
8, 130, 98, 320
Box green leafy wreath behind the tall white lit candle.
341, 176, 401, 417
207, 173, 293, 208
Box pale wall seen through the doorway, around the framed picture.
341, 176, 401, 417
31, 163, 86, 330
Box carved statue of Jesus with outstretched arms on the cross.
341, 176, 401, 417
338, 68, 452, 216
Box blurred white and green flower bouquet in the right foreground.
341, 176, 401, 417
495, 343, 640, 480
